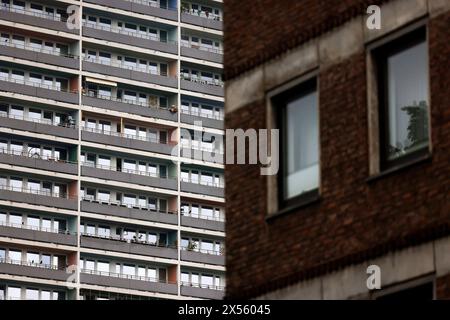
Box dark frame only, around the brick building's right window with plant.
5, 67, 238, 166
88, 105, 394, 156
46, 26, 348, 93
371, 25, 431, 172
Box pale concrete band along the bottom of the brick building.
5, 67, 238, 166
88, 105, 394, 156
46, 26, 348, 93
257, 237, 450, 300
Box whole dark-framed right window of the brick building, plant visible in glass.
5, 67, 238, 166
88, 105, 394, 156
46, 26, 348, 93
374, 27, 429, 170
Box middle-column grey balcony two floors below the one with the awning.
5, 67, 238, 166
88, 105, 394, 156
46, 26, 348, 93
81, 162, 177, 190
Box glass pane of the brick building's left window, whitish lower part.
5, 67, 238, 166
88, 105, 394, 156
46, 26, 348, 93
284, 92, 319, 199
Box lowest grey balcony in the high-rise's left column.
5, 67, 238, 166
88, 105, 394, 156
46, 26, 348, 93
0, 258, 70, 281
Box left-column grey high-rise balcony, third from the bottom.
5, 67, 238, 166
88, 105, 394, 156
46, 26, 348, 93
0, 186, 78, 210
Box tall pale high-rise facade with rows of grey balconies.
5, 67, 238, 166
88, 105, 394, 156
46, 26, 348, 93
0, 0, 225, 300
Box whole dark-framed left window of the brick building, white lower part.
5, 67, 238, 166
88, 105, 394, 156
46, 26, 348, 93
273, 79, 319, 209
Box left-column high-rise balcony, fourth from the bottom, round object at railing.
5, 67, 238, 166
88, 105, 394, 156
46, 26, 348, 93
0, 149, 78, 175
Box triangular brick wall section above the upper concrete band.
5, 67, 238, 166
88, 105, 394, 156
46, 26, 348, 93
224, 0, 388, 78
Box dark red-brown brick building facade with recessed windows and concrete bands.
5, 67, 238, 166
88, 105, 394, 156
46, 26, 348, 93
224, 0, 450, 299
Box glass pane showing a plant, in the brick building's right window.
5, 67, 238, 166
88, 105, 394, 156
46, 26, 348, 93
387, 42, 428, 160
